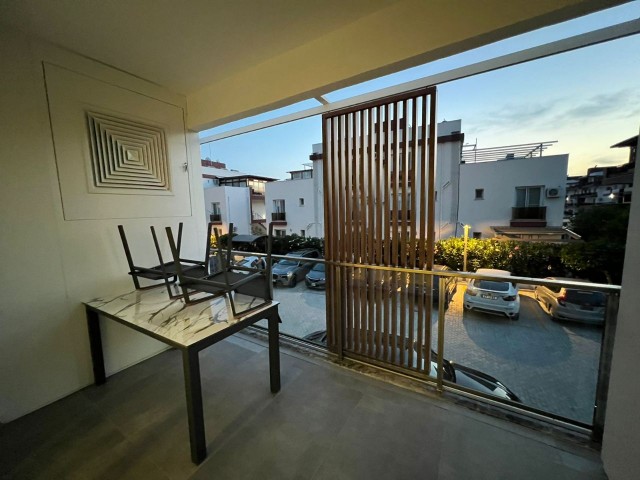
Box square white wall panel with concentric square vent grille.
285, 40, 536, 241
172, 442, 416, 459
44, 63, 192, 220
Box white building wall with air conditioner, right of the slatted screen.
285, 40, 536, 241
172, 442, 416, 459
459, 155, 569, 238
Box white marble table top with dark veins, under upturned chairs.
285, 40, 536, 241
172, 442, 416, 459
84, 285, 278, 347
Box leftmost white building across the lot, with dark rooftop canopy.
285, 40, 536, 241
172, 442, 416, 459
202, 160, 276, 235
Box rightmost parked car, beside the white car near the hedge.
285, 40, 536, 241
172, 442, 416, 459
535, 277, 607, 325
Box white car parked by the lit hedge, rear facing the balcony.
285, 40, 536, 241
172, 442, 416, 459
464, 268, 520, 320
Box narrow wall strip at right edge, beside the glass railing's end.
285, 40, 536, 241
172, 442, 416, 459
602, 133, 640, 480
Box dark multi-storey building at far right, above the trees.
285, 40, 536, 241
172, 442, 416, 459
564, 135, 638, 224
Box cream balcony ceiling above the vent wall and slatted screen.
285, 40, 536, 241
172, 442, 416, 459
0, 0, 624, 130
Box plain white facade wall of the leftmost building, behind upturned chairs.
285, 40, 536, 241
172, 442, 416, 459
204, 186, 251, 235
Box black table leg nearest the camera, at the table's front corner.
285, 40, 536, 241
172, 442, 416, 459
182, 349, 207, 464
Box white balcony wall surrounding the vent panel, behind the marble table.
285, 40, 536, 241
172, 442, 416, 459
0, 29, 204, 422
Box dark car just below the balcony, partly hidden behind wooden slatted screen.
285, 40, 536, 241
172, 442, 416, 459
303, 330, 521, 402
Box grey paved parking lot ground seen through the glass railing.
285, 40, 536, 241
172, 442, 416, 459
258, 283, 602, 423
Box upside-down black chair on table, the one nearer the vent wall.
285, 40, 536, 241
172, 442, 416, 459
118, 222, 211, 298
